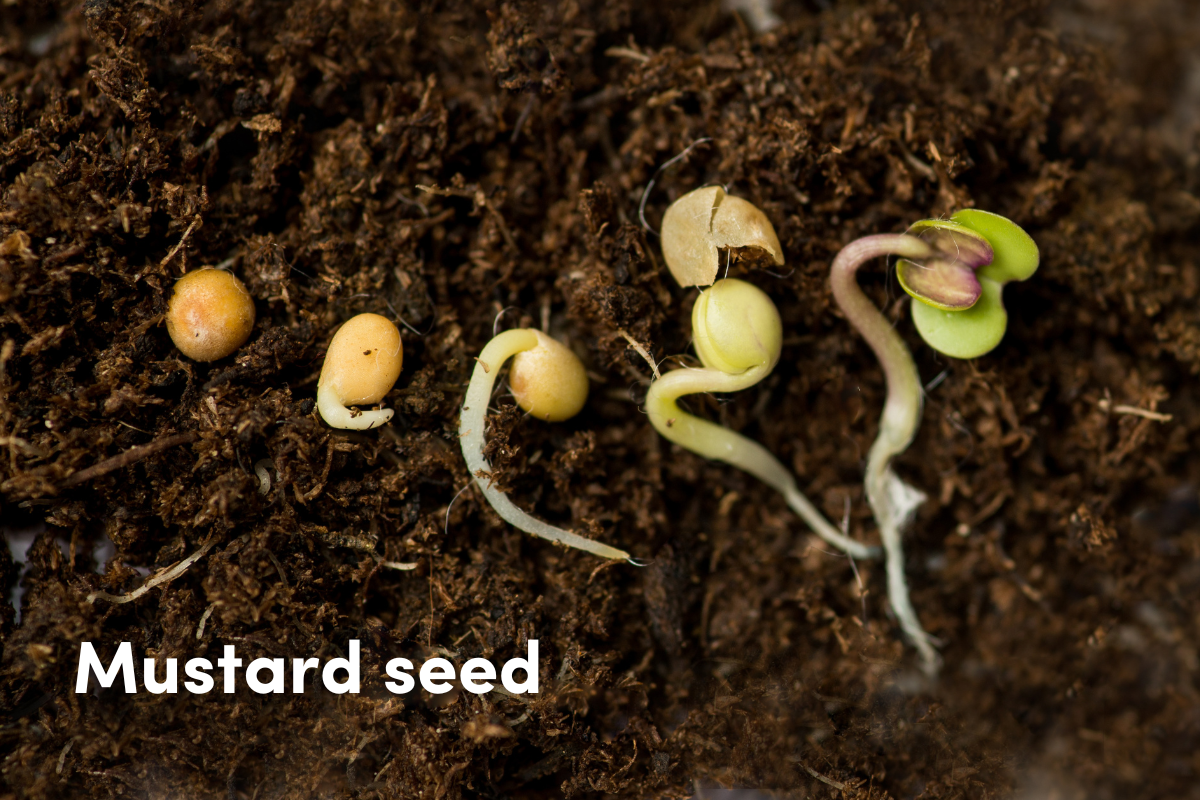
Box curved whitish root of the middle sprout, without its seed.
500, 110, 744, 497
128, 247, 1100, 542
458, 329, 630, 561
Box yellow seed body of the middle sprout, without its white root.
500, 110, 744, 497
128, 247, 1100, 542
509, 331, 588, 422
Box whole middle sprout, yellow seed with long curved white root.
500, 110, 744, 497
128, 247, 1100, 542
458, 329, 630, 561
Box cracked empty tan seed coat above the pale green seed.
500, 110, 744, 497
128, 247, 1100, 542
661, 186, 784, 287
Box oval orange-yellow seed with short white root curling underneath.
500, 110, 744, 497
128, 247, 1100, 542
317, 314, 404, 431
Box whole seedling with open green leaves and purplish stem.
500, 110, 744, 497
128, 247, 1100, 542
830, 210, 1038, 673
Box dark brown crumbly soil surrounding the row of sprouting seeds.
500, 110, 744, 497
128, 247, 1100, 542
0, 0, 1200, 800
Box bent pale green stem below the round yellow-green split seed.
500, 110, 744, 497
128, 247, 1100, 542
646, 365, 878, 559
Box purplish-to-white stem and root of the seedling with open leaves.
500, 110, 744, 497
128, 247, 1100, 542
830, 234, 940, 674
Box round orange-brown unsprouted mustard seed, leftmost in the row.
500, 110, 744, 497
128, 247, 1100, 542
167, 267, 254, 361
